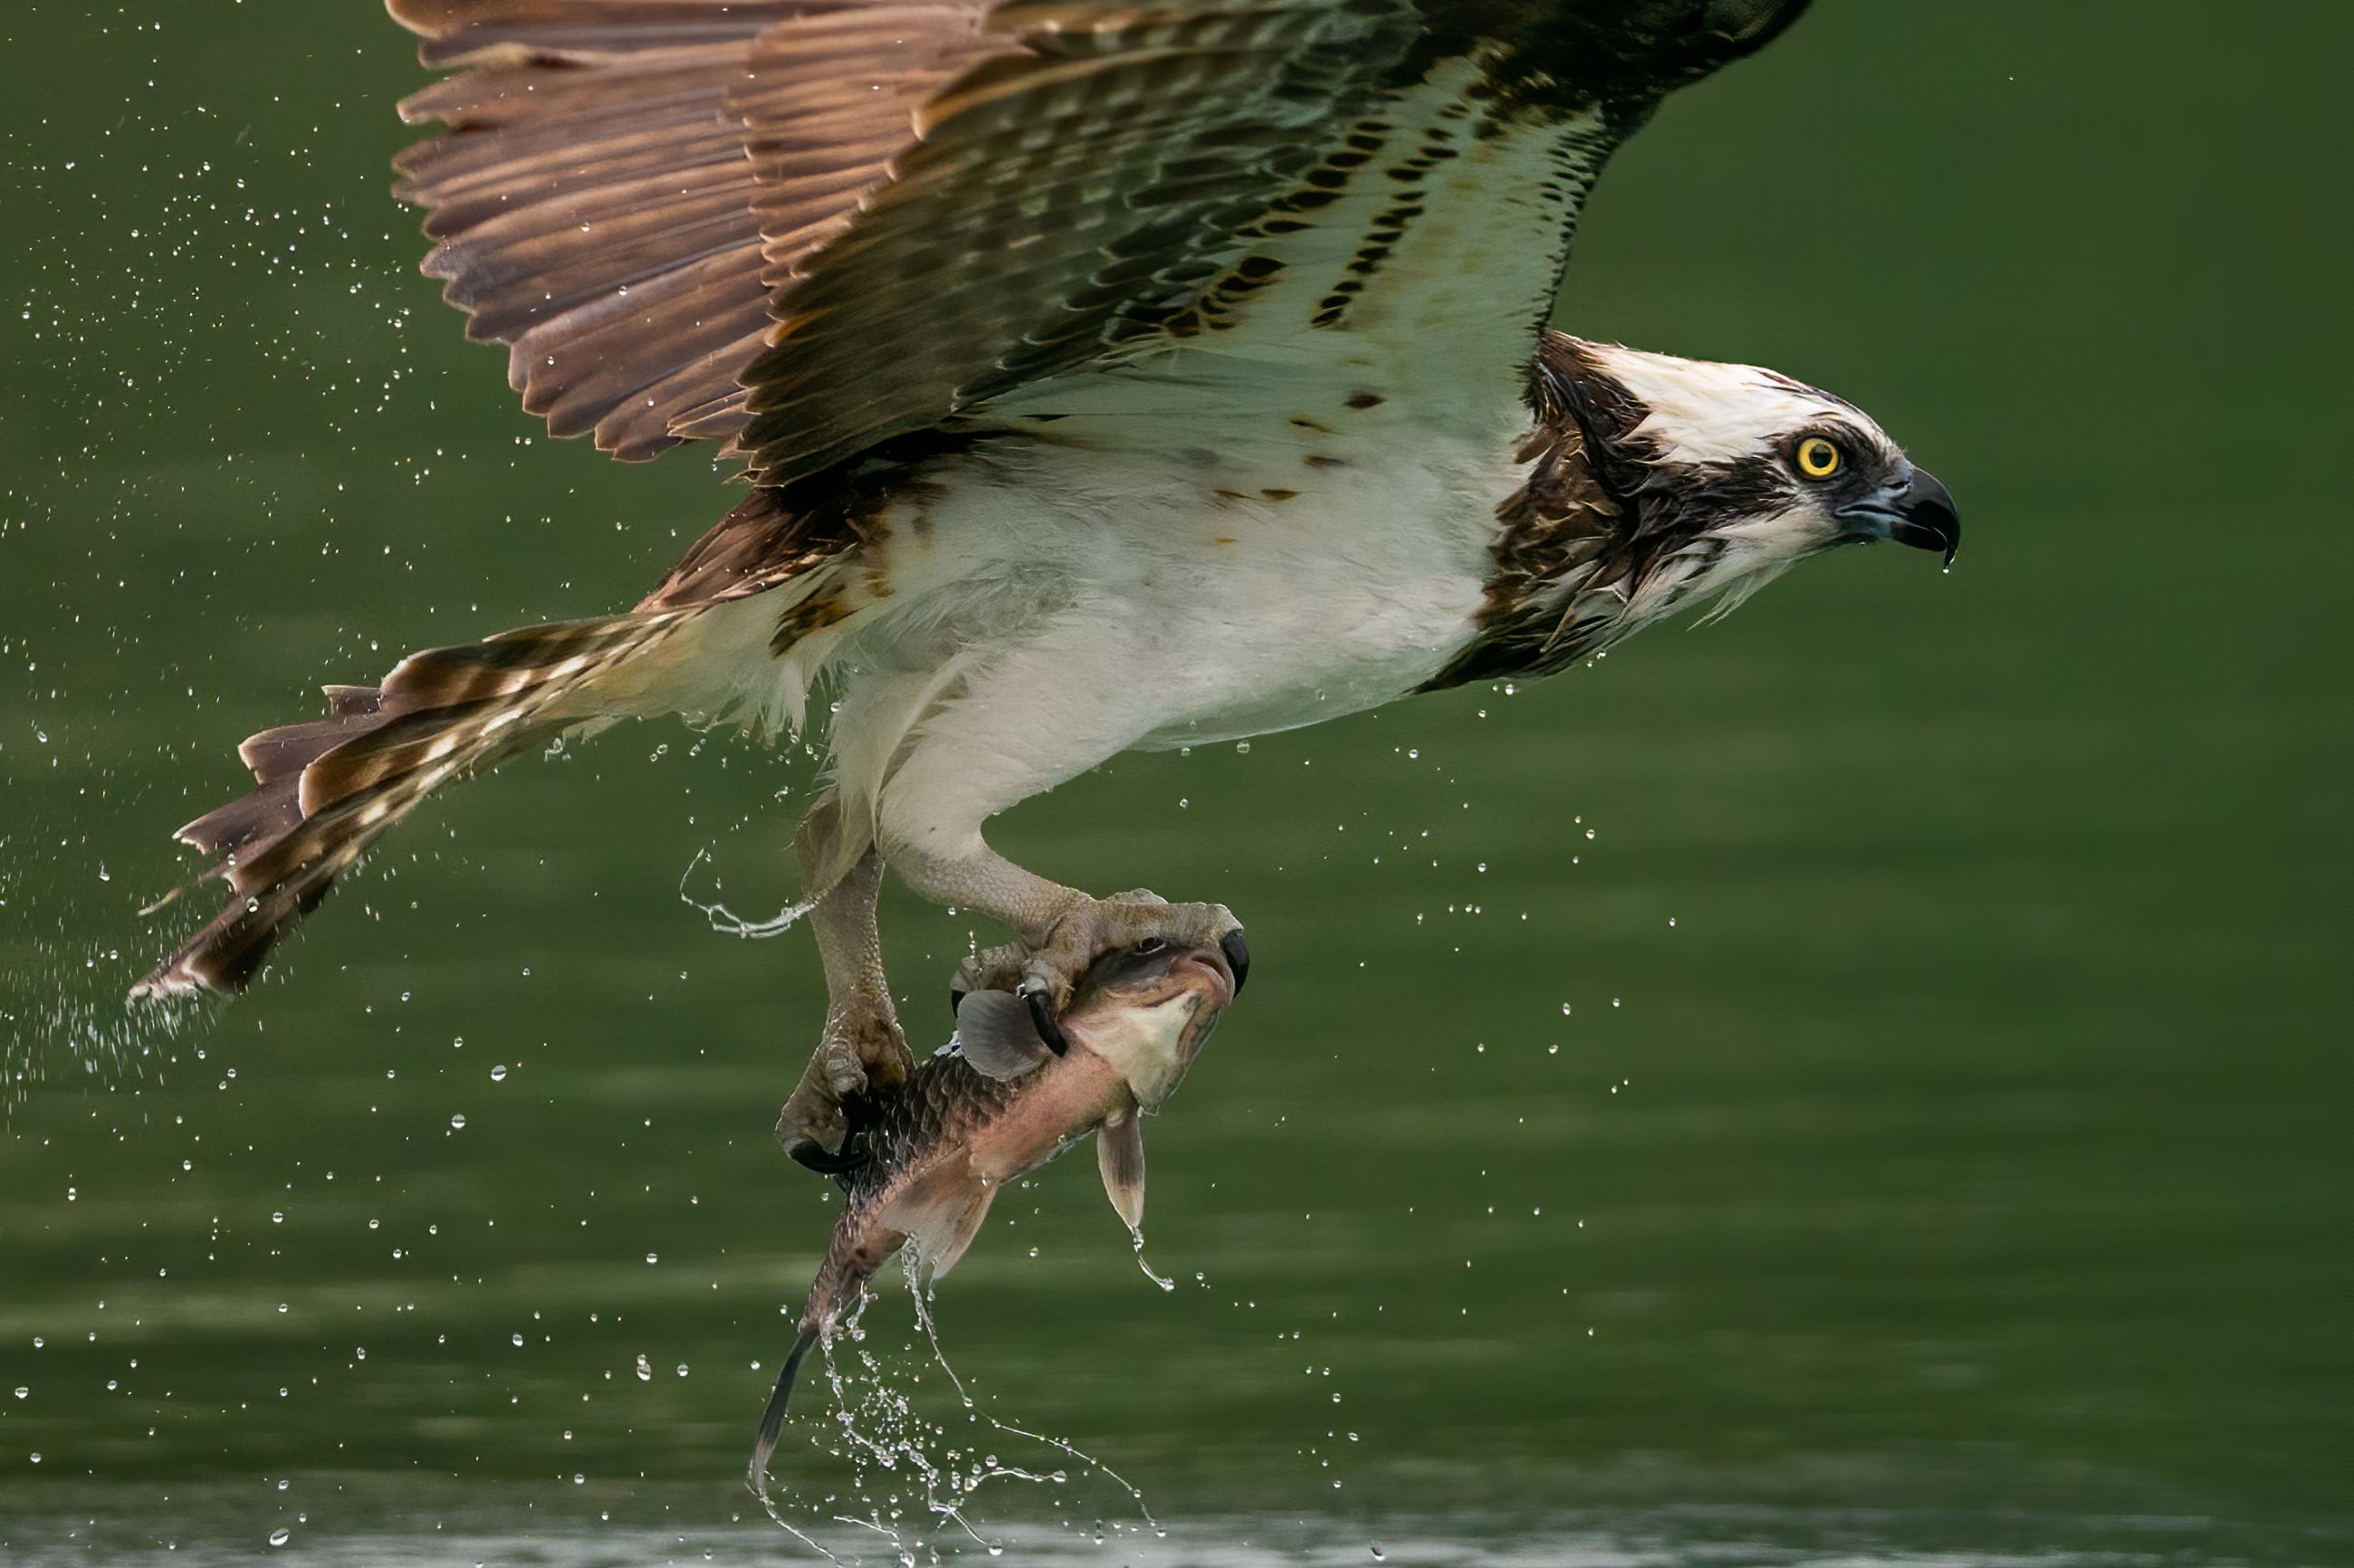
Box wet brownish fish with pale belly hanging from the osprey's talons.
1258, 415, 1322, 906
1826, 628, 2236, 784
746, 934, 1250, 1488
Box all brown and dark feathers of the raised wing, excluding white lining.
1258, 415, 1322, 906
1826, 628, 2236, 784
388, 0, 1805, 483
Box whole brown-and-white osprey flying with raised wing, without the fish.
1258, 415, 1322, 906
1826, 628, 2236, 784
139, 0, 1958, 1168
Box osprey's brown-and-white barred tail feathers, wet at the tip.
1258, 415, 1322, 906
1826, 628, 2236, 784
132, 610, 697, 996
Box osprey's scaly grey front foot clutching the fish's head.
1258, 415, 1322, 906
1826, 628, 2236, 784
892, 843, 1250, 1055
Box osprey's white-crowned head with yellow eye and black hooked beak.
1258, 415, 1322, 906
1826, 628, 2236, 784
1545, 337, 1961, 622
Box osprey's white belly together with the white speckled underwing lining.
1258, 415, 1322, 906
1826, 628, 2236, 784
771, 66, 1586, 843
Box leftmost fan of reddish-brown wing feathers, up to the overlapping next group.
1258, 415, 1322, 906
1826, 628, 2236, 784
393, 0, 791, 459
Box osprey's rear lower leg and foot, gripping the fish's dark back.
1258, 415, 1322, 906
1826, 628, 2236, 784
777, 847, 915, 1172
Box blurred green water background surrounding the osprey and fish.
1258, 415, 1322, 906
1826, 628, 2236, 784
0, 0, 2354, 1563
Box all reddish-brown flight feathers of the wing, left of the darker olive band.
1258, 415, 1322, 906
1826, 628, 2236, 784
391, 0, 1015, 459
